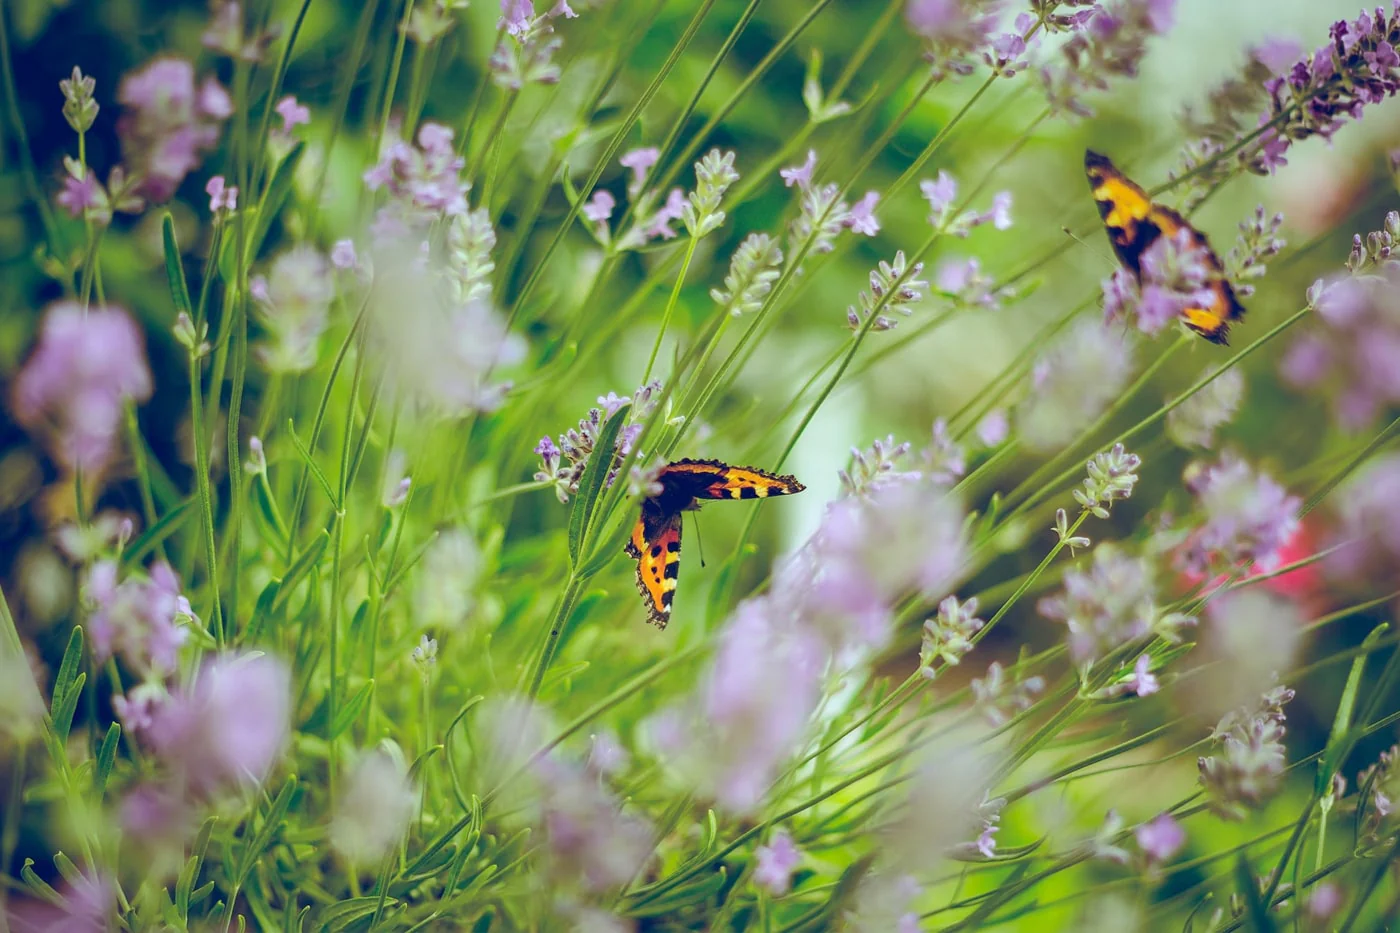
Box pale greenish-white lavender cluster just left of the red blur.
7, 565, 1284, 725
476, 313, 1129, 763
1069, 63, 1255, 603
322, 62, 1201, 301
1037, 544, 1196, 667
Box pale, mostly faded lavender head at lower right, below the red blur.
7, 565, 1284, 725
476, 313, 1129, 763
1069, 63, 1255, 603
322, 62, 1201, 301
1197, 686, 1294, 820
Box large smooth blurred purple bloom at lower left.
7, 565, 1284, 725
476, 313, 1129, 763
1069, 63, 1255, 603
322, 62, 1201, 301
137, 654, 291, 797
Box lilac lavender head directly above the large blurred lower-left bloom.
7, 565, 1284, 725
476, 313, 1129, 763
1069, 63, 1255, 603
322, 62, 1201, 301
85, 560, 197, 679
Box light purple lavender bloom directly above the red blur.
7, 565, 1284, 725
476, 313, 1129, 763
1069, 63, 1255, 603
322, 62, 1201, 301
1182, 455, 1302, 573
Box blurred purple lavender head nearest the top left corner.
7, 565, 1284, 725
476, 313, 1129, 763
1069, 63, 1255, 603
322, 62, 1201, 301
116, 57, 234, 202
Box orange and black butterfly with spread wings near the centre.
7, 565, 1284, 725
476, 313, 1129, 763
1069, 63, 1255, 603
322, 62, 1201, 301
627, 459, 806, 629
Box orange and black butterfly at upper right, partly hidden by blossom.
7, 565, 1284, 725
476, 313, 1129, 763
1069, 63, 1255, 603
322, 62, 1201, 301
1084, 150, 1245, 345
